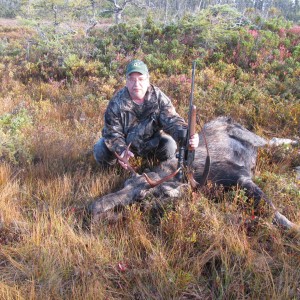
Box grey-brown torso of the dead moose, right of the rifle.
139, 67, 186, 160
193, 117, 270, 205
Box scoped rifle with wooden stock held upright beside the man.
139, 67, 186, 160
176, 61, 196, 181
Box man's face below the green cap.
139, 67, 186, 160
126, 72, 150, 100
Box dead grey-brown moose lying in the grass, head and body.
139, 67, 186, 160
91, 117, 296, 228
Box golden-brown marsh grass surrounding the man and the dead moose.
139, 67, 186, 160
0, 21, 300, 299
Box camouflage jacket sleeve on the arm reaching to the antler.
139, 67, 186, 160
102, 101, 126, 154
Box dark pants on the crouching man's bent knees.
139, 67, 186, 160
94, 134, 177, 166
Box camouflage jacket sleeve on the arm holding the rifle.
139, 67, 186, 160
158, 90, 187, 142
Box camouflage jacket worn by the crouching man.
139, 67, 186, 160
102, 85, 187, 155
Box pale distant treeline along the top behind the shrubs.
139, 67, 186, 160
0, 0, 300, 23
